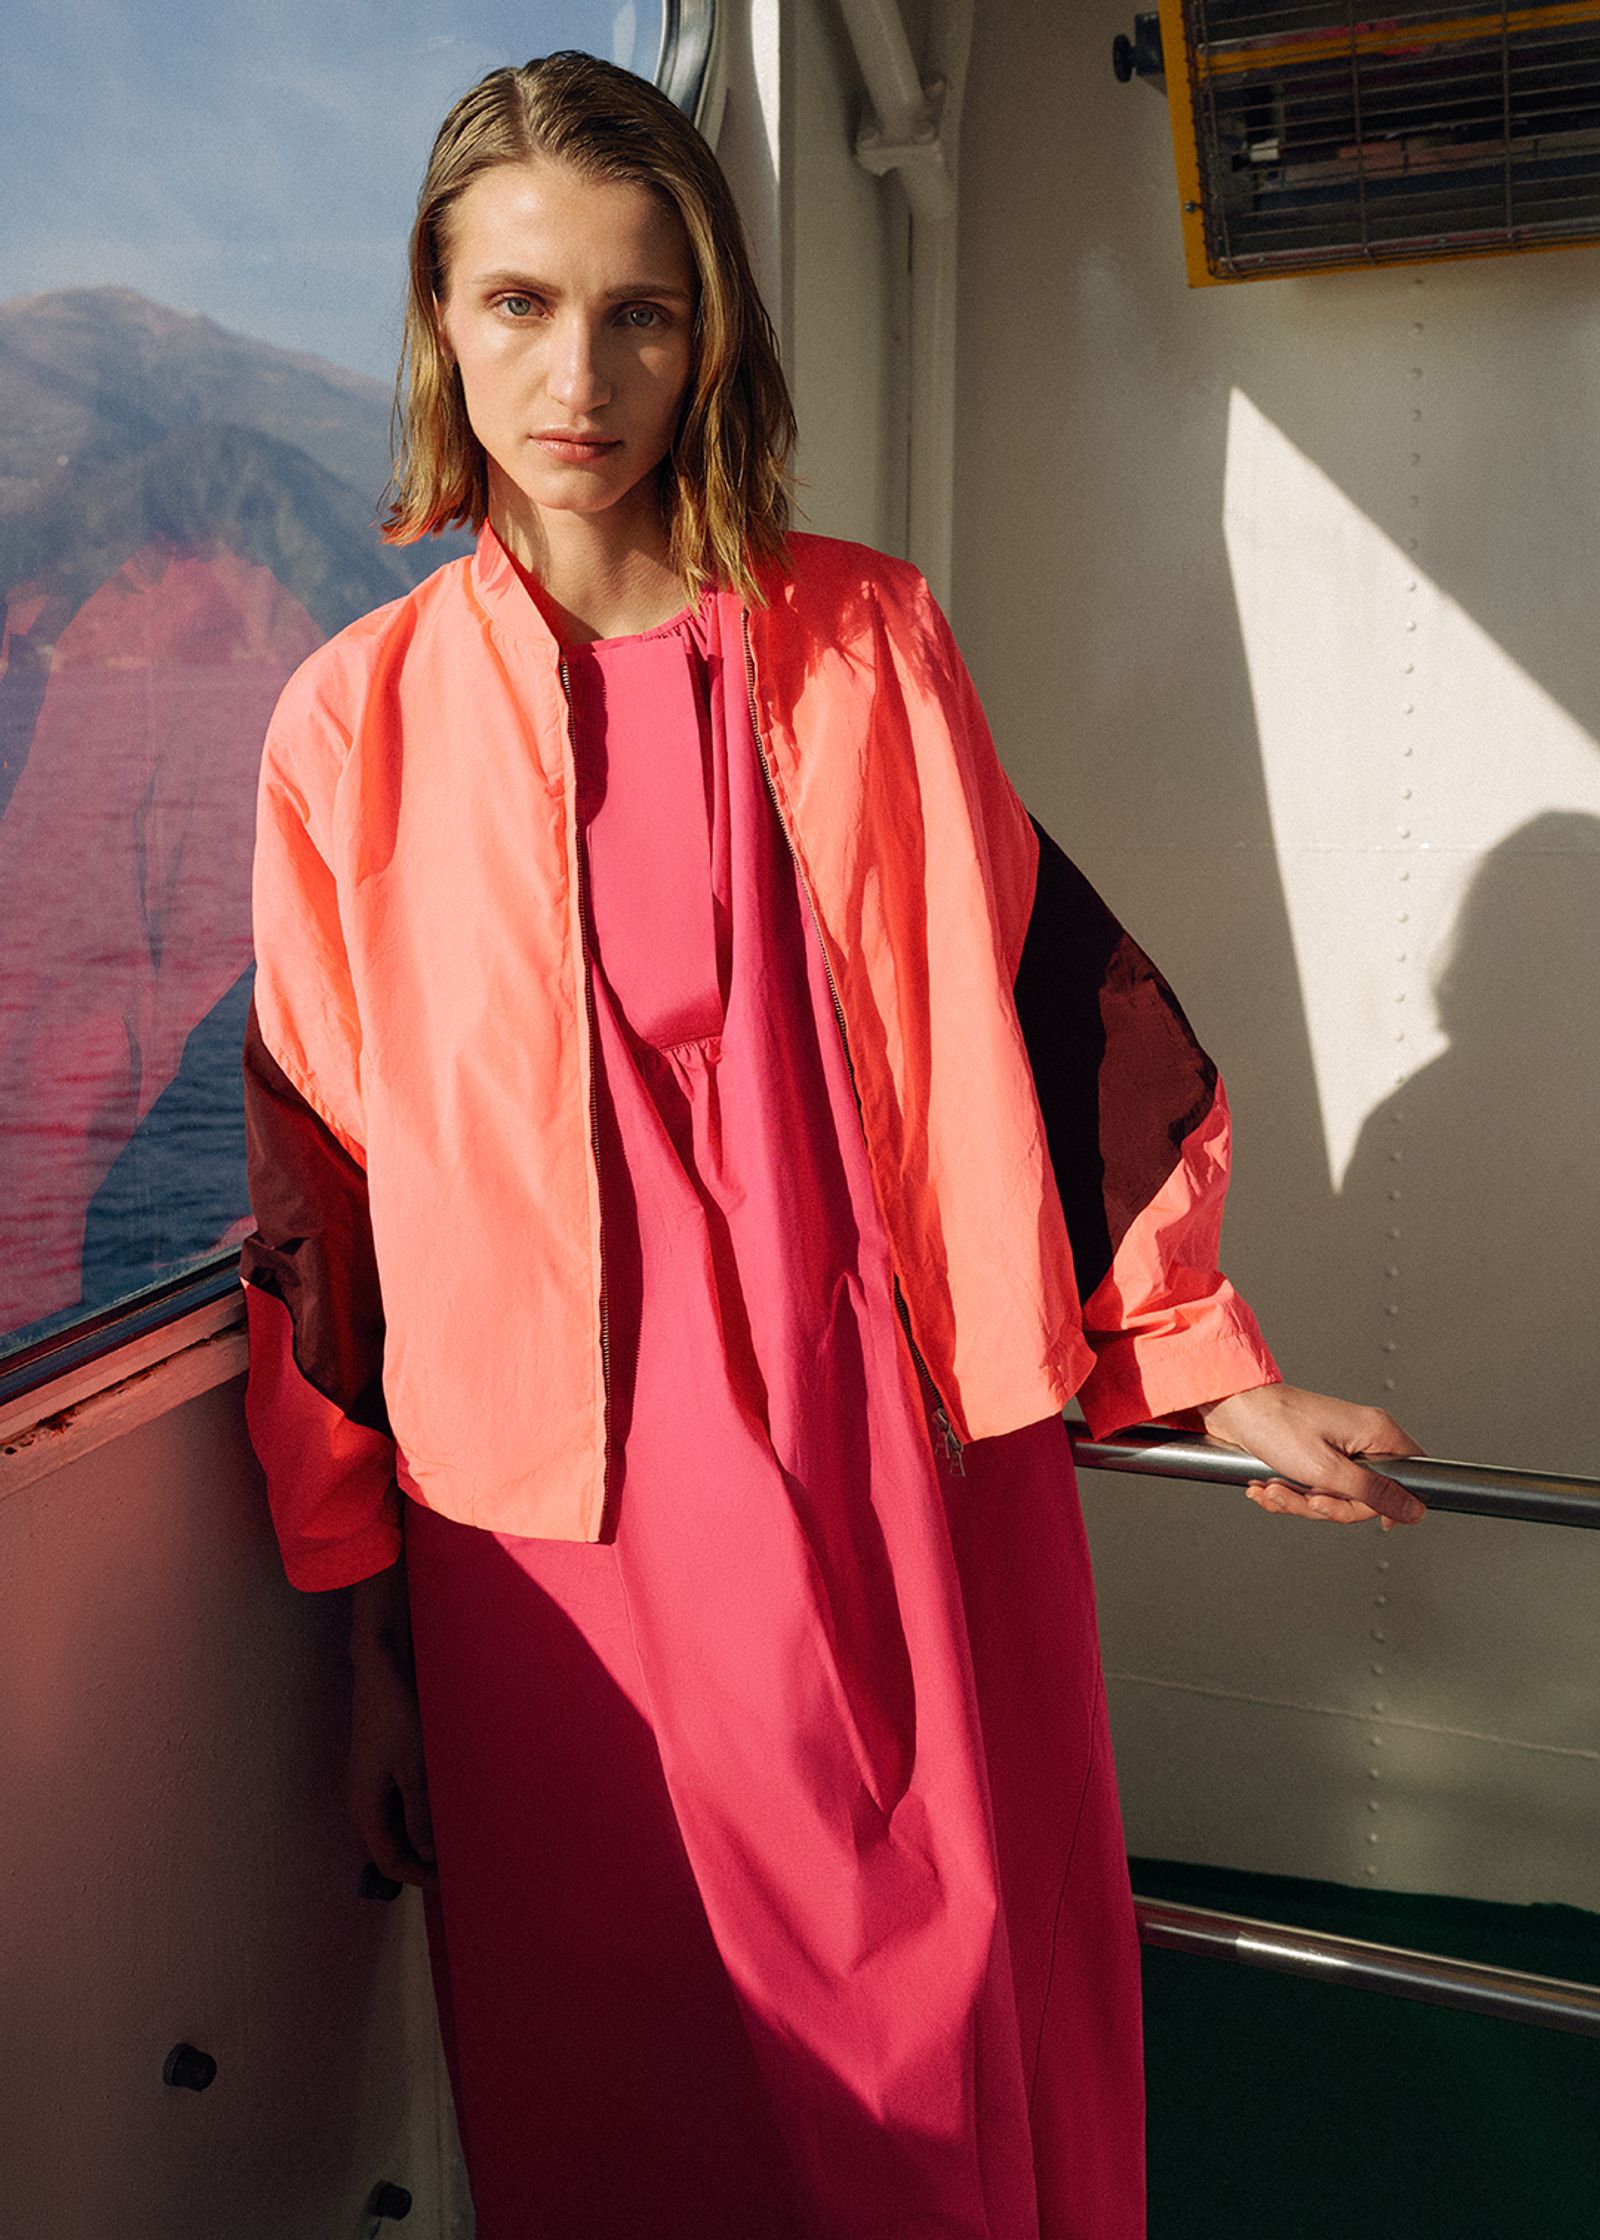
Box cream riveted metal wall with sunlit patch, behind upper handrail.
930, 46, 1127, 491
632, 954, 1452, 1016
955, 0, 1600, 1906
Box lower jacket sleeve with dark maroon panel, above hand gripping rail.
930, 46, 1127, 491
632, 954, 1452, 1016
1015, 824, 1280, 1436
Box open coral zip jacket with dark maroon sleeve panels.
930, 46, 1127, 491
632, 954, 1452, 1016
242, 529, 1277, 1586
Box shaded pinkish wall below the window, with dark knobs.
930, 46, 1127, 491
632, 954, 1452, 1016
0, 1380, 468, 2240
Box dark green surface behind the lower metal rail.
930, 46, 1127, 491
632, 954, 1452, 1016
1132, 1859, 1600, 2240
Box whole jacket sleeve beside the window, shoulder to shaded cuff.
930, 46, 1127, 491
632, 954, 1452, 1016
240, 672, 401, 1588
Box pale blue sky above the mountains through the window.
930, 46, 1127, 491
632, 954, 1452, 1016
0, 0, 661, 383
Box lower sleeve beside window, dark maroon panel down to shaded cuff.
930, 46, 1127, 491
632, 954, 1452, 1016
240, 1006, 401, 1588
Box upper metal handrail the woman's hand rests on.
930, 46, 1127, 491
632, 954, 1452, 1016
1067, 1418, 1600, 1528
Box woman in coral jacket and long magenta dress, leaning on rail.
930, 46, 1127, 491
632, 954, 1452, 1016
244, 56, 1421, 2240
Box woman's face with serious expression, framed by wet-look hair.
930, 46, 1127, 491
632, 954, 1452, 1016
439, 159, 695, 542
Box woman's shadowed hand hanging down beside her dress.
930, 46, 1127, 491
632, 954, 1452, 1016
345, 1559, 435, 1891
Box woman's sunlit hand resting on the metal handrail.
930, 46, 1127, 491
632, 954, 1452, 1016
1197, 1384, 1427, 1532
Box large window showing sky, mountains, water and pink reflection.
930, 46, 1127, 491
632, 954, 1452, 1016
0, 0, 710, 1389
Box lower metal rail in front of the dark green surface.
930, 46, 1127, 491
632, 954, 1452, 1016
1134, 1897, 1600, 2038
